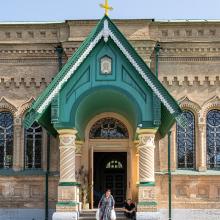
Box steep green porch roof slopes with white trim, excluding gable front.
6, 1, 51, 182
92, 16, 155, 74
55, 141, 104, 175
24, 16, 186, 136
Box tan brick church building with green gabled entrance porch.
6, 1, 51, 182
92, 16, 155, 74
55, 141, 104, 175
0, 7, 220, 220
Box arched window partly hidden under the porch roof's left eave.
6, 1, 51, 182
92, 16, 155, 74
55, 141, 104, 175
25, 122, 42, 169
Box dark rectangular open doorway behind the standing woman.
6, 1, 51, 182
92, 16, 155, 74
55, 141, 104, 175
93, 152, 127, 207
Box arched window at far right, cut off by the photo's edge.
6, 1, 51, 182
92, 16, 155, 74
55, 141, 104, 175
206, 110, 220, 168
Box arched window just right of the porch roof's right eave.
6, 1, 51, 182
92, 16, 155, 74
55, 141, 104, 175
177, 111, 195, 169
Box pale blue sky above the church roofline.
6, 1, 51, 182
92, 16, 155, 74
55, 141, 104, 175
0, 0, 220, 21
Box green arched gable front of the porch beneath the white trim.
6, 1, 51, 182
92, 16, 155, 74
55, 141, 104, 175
52, 40, 155, 138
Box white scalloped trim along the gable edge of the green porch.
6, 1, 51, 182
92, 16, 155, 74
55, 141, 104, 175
37, 20, 175, 114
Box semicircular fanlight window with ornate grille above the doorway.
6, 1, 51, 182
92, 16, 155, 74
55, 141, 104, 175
89, 117, 128, 139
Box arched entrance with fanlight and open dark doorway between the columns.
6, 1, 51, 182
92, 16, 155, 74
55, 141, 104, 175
86, 112, 133, 207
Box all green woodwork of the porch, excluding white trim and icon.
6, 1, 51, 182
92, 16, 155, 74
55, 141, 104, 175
24, 16, 181, 139
